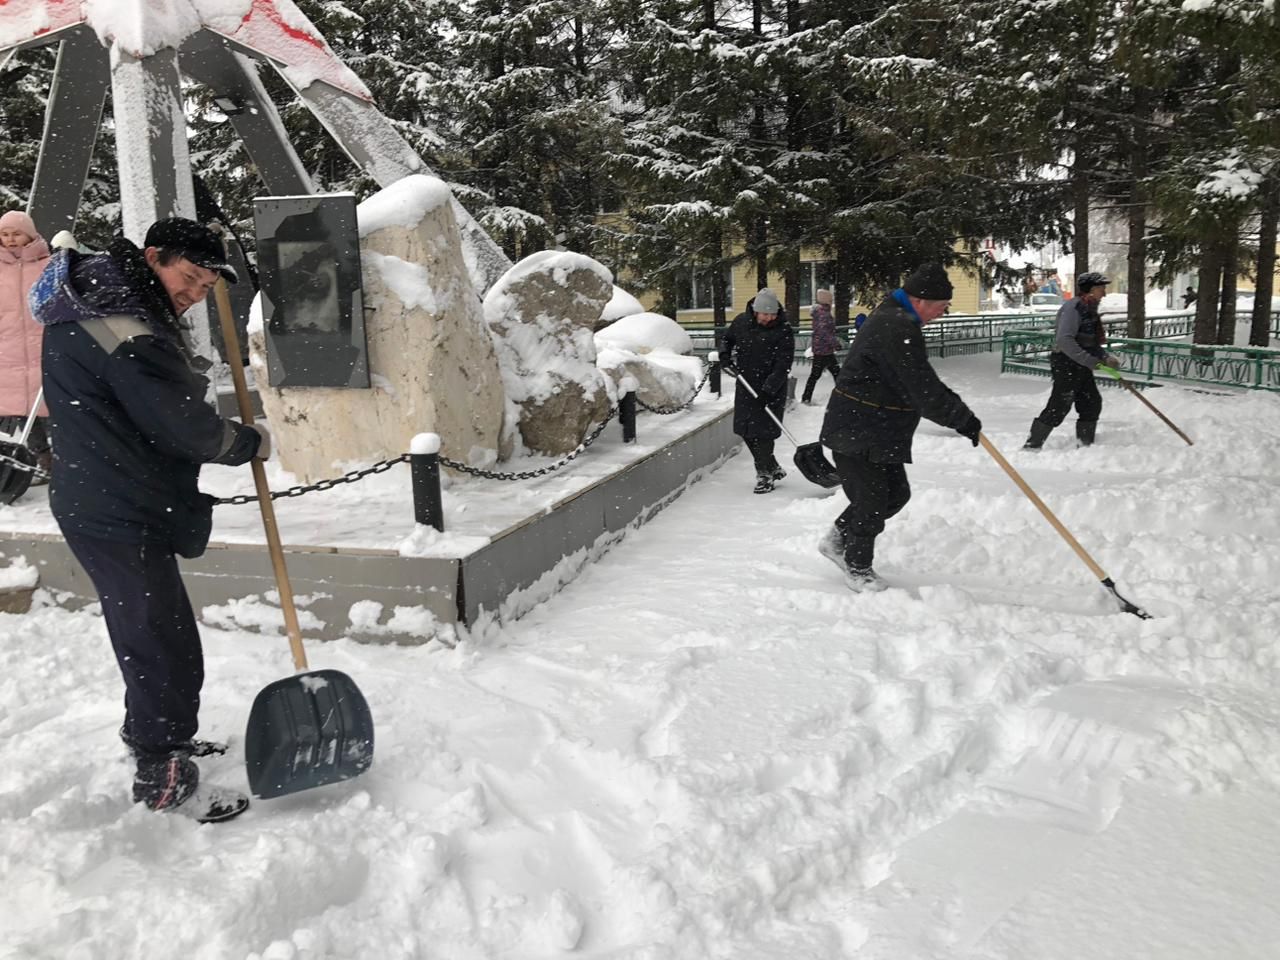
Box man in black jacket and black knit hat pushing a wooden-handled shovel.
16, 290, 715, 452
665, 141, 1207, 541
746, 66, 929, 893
818, 264, 982, 590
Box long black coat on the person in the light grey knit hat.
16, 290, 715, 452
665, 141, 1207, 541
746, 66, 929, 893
721, 300, 796, 440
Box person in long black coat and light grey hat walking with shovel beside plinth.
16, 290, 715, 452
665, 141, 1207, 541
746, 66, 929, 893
719, 288, 796, 493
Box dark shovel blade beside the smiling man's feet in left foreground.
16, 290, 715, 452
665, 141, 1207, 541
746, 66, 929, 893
244, 669, 374, 799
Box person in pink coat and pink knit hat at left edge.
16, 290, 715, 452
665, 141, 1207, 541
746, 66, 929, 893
0, 210, 50, 470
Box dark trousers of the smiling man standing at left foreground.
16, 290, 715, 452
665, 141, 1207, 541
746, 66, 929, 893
63, 530, 205, 754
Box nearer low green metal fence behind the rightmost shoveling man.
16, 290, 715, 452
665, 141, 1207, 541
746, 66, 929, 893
1000, 327, 1280, 392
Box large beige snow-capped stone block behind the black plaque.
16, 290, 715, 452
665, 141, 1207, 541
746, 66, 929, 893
250, 175, 506, 483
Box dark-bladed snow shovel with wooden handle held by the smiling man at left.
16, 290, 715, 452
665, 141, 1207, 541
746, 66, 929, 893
214, 279, 374, 797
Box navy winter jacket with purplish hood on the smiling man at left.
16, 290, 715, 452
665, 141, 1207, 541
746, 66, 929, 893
29, 238, 261, 557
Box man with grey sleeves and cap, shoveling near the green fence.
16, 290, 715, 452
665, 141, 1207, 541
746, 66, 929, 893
1023, 271, 1120, 451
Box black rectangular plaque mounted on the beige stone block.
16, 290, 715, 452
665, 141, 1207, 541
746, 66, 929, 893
253, 193, 369, 388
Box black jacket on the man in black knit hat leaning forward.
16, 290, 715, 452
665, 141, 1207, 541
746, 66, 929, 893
822, 291, 973, 463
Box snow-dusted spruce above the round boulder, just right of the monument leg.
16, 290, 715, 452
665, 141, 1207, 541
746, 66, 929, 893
416, 0, 616, 260
